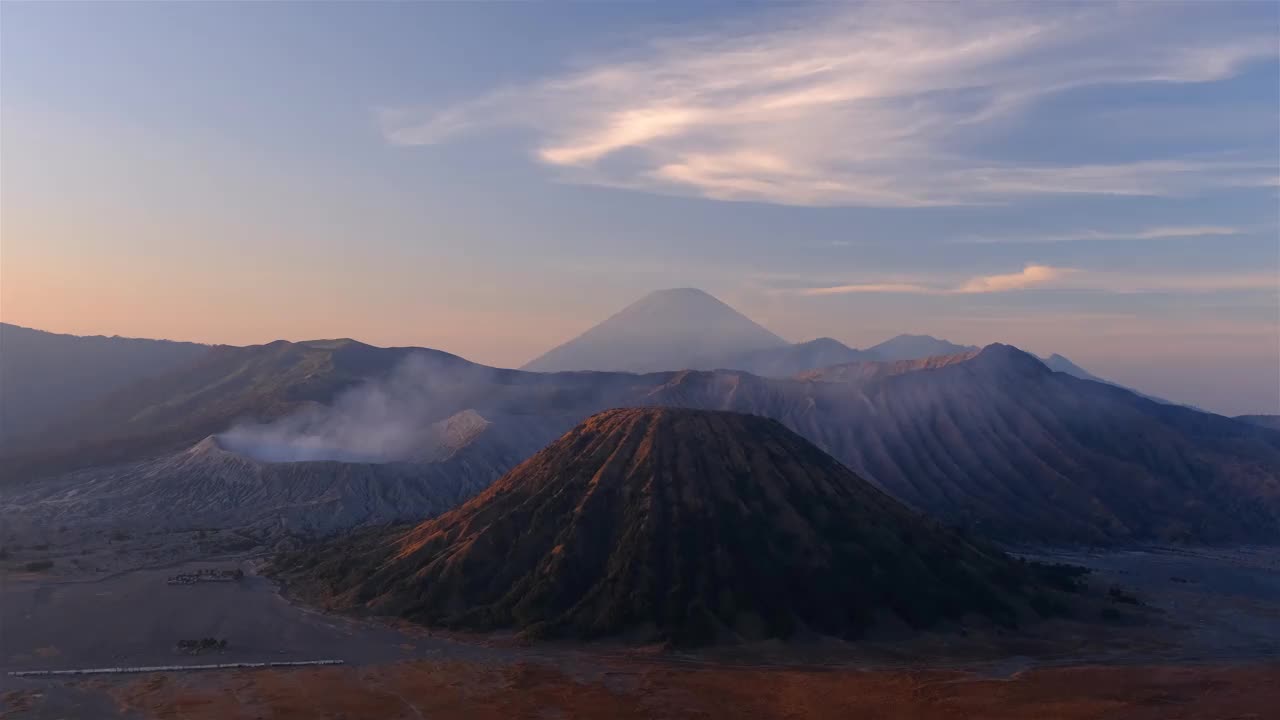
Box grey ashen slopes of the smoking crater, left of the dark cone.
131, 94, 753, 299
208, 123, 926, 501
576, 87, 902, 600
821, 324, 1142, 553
0, 414, 529, 537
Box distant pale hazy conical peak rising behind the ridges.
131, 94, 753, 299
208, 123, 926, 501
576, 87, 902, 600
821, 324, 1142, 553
522, 288, 787, 373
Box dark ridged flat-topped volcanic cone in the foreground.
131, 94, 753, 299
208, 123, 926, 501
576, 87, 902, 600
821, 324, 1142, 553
278, 409, 1070, 644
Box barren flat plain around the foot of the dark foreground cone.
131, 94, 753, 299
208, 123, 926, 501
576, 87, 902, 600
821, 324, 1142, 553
0, 540, 1280, 720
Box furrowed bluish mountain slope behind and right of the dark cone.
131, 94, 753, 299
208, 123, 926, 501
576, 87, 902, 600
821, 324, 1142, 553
650, 345, 1280, 543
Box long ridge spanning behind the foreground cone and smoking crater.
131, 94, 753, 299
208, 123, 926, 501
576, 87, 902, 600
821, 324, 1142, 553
0, 333, 1280, 543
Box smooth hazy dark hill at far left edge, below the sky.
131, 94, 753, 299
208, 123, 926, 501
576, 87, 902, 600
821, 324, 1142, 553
0, 323, 209, 452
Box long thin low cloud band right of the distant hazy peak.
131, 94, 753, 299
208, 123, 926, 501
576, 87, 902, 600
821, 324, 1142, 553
776, 264, 1280, 297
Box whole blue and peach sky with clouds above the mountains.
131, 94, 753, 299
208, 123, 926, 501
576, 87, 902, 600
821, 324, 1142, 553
0, 1, 1280, 414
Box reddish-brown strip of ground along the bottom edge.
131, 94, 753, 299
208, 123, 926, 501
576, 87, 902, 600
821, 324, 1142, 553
0, 660, 1280, 720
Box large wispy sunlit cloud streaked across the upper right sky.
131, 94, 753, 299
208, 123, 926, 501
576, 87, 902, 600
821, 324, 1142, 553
380, 3, 1276, 206
